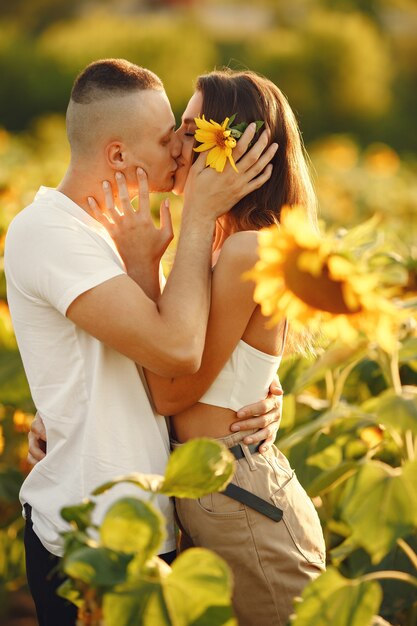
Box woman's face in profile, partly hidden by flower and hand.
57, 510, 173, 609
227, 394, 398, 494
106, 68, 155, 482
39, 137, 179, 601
172, 91, 203, 195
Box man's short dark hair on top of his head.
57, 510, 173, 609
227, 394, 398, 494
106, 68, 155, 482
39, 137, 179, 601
71, 59, 164, 104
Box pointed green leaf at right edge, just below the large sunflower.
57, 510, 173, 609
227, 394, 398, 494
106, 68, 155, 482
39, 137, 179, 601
362, 387, 417, 435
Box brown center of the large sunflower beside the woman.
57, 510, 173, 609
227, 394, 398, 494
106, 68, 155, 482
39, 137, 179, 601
284, 248, 360, 315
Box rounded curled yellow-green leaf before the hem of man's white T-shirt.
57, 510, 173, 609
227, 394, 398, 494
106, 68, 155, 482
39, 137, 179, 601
100, 498, 165, 562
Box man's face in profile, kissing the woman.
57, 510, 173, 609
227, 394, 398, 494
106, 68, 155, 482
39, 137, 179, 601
119, 89, 181, 191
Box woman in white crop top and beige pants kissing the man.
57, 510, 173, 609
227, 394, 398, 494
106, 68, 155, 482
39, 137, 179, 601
98, 71, 325, 626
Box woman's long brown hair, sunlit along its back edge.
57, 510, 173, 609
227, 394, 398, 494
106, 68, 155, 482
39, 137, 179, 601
196, 68, 316, 230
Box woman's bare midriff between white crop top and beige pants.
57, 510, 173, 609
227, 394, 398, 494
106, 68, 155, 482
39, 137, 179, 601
171, 403, 240, 443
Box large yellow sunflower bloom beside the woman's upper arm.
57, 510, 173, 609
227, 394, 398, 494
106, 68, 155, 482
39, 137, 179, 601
245, 207, 399, 352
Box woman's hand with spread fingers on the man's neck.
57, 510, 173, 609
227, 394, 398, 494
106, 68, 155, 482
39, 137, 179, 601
88, 168, 174, 299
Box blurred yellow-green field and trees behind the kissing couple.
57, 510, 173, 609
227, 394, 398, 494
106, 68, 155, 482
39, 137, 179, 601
0, 0, 417, 626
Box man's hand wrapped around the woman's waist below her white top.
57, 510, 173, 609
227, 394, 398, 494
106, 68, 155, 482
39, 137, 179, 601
231, 376, 283, 453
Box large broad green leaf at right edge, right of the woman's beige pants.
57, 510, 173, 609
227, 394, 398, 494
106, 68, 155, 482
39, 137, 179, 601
340, 461, 417, 563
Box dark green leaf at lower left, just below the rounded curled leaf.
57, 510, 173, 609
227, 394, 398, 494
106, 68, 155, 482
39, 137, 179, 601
63, 547, 132, 588
